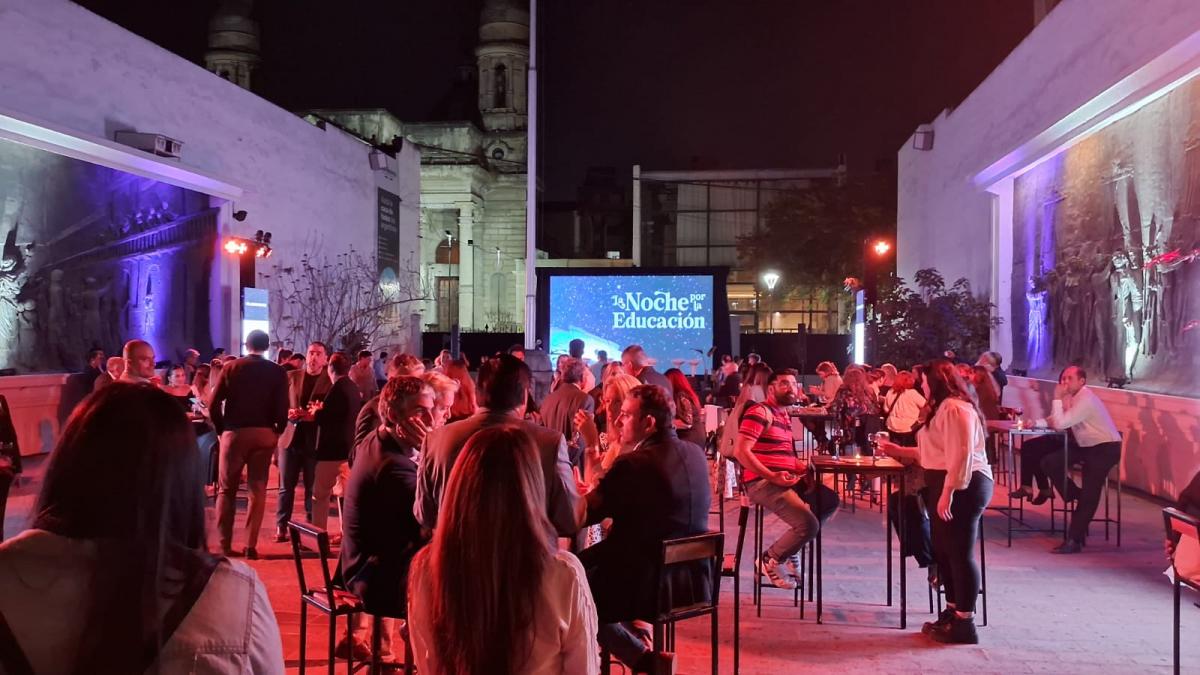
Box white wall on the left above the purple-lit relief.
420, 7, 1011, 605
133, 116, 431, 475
0, 0, 420, 355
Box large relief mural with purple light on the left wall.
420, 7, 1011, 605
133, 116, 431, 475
0, 141, 216, 372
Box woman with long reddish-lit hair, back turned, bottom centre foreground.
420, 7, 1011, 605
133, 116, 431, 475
408, 425, 600, 675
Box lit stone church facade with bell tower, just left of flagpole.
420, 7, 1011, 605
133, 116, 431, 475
308, 0, 529, 331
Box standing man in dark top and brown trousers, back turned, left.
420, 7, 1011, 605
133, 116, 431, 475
208, 330, 288, 558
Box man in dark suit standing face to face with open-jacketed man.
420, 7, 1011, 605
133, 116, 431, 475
312, 352, 362, 535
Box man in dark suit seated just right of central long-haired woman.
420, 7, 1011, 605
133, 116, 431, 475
580, 384, 705, 673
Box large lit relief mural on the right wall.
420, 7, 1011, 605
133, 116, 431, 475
1013, 82, 1200, 396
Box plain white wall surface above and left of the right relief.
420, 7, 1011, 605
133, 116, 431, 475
896, 0, 1200, 293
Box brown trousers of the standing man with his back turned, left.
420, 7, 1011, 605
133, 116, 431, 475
217, 426, 280, 550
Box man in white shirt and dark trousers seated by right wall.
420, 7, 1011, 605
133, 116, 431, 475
1018, 365, 1121, 554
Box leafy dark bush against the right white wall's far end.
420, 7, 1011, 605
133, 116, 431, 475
866, 269, 1000, 368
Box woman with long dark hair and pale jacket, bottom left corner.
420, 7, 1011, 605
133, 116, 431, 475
0, 382, 283, 673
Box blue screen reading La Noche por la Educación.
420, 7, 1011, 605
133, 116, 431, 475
550, 275, 713, 372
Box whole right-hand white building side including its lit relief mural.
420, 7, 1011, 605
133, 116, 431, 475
896, 0, 1200, 498
